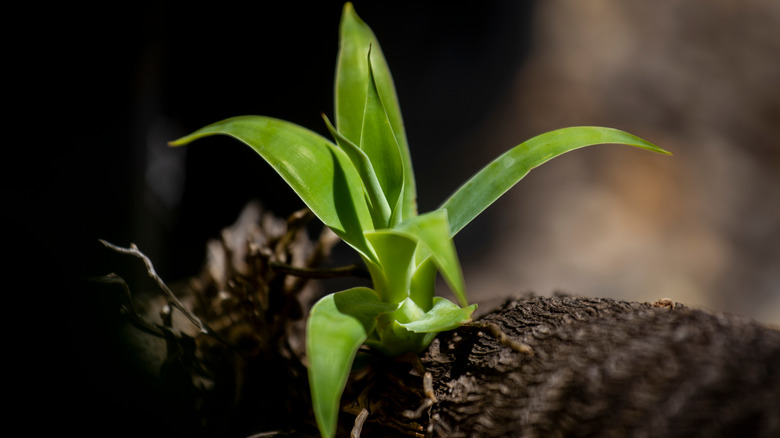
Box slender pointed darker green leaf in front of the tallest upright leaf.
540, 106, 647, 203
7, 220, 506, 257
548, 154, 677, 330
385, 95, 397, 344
360, 49, 404, 227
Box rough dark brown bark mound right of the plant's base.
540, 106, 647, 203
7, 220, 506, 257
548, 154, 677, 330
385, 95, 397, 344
414, 297, 780, 437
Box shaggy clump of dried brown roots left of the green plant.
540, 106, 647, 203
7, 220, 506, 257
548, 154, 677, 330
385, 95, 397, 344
95, 203, 344, 436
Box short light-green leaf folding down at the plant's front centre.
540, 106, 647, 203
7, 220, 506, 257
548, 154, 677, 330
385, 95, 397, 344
392, 209, 468, 307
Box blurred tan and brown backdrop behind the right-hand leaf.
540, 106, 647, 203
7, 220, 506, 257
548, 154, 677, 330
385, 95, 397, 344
465, 0, 780, 324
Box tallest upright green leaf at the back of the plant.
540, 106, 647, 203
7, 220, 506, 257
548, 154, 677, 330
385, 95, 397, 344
335, 3, 417, 218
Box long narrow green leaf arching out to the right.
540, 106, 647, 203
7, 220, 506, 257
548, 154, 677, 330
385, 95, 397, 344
441, 126, 671, 236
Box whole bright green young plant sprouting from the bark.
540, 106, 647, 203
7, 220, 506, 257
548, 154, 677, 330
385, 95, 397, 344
170, 3, 668, 436
